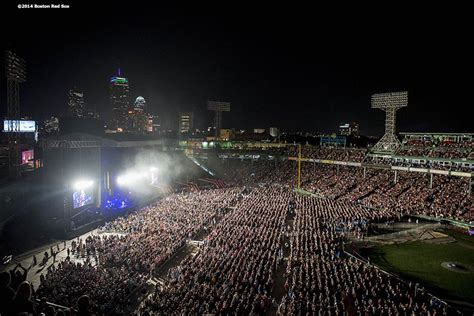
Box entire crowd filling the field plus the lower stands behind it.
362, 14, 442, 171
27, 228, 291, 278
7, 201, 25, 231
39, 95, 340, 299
0, 159, 474, 315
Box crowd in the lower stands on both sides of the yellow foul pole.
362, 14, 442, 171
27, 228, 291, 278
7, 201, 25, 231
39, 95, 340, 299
206, 160, 474, 222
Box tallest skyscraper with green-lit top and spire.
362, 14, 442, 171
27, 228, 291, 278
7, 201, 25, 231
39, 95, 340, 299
110, 68, 130, 131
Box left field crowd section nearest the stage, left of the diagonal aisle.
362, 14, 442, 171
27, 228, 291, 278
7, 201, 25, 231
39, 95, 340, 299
18, 188, 237, 315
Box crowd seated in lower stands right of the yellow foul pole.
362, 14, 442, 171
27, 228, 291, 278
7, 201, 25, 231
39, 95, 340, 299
296, 165, 474, 222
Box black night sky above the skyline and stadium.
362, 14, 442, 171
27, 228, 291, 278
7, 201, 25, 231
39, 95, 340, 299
0, 0, 474, 135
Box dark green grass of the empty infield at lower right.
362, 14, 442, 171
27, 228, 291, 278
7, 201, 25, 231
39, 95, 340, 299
366, 231, 474, 303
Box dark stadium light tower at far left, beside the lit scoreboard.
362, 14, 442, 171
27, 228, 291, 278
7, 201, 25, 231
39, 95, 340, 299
5, 50, 26, 178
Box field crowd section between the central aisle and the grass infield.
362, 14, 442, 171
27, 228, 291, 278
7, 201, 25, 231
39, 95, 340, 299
278, 196, 446, 315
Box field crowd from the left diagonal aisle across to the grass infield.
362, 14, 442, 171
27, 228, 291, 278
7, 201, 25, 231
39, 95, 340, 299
141, 185, 446, 315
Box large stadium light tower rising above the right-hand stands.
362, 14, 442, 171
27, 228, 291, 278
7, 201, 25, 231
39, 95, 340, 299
371, 91, 408, 152
